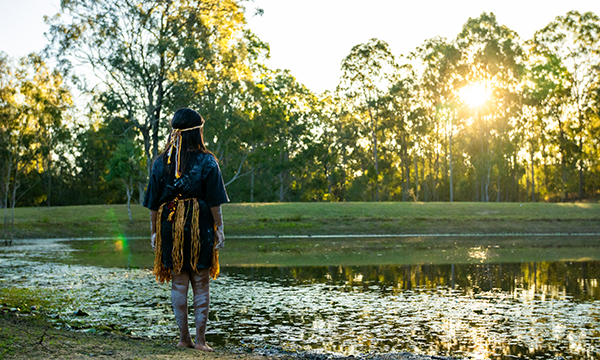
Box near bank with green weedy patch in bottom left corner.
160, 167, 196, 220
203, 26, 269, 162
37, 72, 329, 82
0, 283, 290, 360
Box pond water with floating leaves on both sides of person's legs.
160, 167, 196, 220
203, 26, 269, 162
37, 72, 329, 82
0, 241, 600, 359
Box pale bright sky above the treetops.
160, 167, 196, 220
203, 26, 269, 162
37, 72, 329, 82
0, 0, 600, 93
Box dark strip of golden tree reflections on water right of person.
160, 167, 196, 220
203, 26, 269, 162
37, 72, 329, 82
223, 261, 600, 300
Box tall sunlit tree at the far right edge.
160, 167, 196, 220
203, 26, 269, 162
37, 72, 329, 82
533, 11, 600, 199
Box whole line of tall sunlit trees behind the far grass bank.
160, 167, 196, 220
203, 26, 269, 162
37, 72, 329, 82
0, 0, 600, 208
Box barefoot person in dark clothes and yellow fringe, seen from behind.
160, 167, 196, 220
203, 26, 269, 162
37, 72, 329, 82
143, 109, 229, 351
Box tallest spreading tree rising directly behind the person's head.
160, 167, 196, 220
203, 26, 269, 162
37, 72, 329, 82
47, 0, 260, 177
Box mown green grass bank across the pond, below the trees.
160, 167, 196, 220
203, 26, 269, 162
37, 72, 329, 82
0, 202, 600, 238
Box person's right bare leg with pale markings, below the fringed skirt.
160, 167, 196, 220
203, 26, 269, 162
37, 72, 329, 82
191, 269, 214, 351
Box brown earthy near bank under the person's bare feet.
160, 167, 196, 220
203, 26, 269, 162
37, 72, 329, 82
0, 310, 451, 360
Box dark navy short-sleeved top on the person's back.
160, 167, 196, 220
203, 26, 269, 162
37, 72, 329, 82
144, 152, 229, 211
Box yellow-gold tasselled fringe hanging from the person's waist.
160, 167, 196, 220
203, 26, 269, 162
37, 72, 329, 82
153, 199, 220, 282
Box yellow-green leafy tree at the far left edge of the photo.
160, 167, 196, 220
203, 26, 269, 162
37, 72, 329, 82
0, 54, 72, 237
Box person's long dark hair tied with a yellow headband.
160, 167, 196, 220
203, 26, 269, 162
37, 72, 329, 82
159, 108, 214, 175
